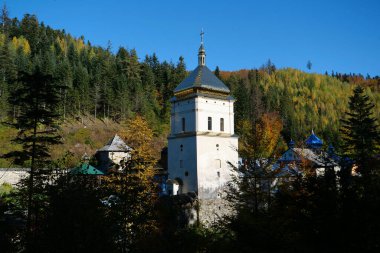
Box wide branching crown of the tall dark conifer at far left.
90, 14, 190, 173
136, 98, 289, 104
7, 67, 60, 167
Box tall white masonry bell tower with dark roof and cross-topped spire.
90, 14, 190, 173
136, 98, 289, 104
168, 33, 238, 222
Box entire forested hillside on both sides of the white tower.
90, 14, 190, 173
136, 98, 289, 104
0, 11, 380, 166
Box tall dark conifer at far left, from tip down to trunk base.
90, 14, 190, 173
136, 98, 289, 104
5, 67, 60, 250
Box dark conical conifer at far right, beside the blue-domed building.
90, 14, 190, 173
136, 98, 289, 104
341, 86, 380, 174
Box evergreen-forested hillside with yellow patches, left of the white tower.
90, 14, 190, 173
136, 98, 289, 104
0, 15, 186, 132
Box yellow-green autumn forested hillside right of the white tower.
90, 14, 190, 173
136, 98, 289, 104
223, 66, 380, 146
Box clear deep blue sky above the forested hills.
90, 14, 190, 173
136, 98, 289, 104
1, 0, 380, 76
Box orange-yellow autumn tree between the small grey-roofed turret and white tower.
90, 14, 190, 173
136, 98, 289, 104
101, 116, 158, 252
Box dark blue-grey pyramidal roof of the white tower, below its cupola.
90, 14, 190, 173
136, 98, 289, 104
174, 66, 230, 93
